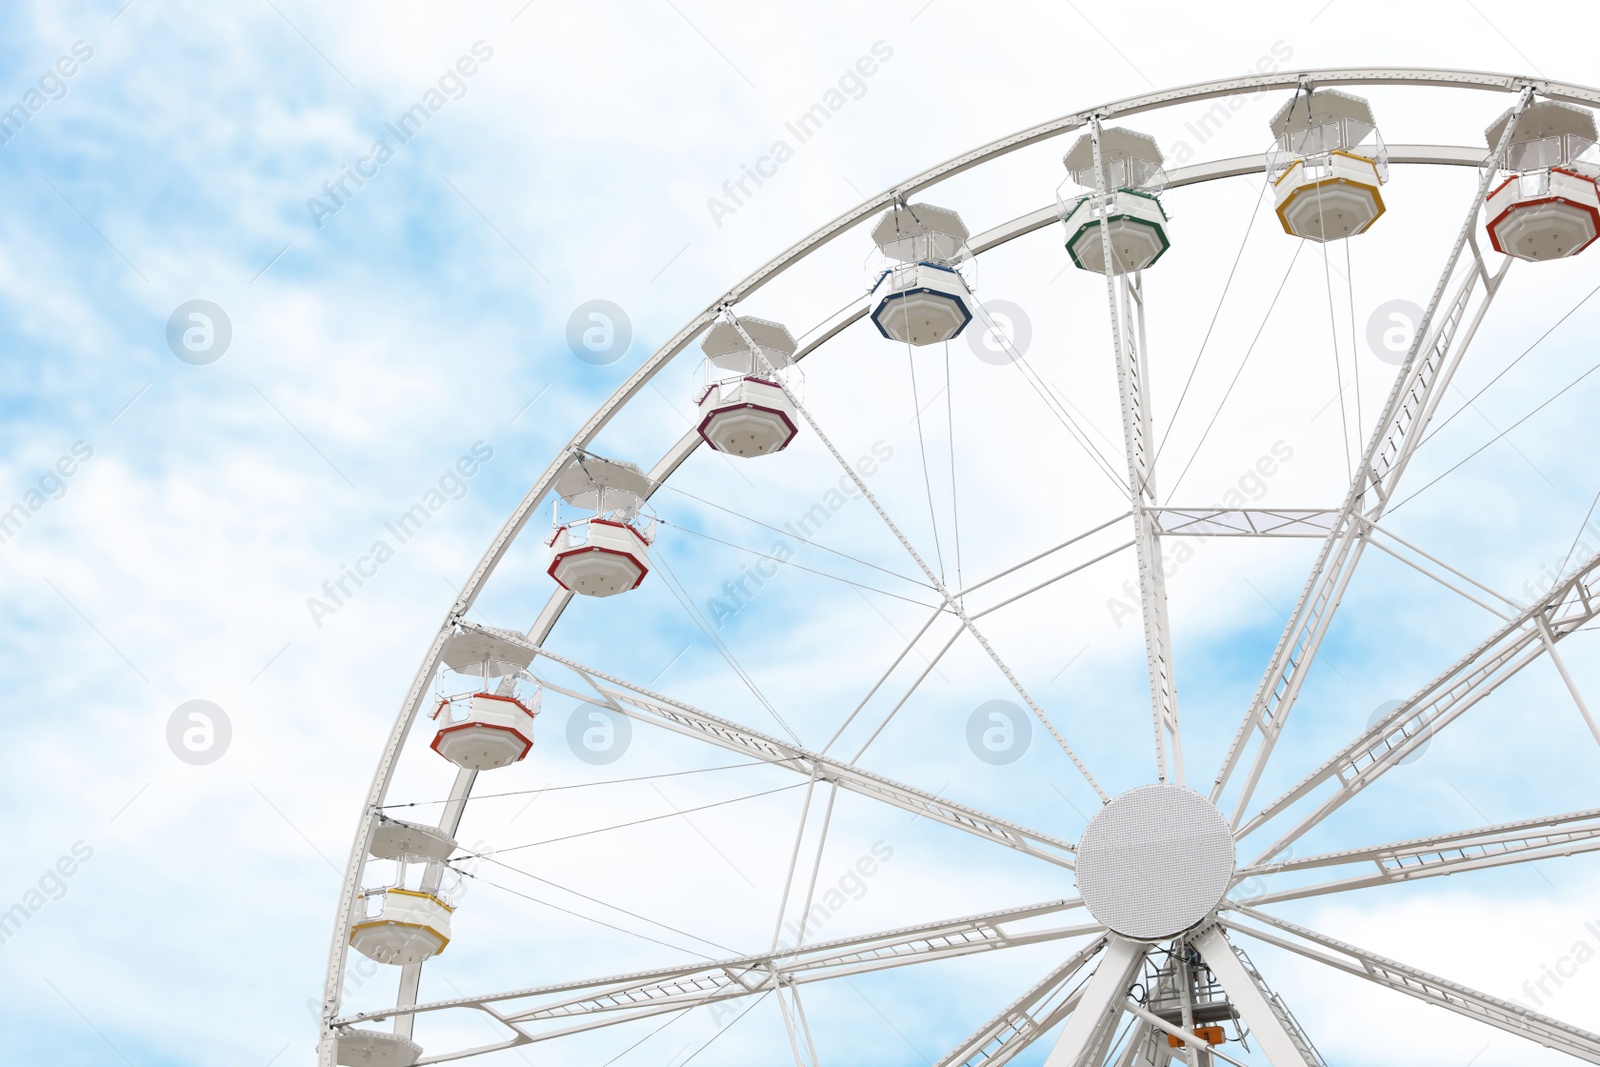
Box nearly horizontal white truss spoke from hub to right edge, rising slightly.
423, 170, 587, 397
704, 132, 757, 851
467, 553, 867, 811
1237, 808, 1600, 905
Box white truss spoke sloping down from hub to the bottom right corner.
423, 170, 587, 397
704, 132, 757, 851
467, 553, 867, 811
1227, 907, 1600, 1064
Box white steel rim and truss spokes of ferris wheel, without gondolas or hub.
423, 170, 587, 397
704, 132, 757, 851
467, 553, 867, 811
318, 69, 1600, 1067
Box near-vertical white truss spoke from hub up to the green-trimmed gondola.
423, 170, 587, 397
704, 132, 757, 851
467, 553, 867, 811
1090, 117, 1184, 785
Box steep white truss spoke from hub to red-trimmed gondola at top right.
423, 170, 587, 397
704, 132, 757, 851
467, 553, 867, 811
1211, 88, 1533, 827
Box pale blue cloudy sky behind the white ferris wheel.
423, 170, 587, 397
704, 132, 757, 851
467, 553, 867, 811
0, 0, 1600, 1067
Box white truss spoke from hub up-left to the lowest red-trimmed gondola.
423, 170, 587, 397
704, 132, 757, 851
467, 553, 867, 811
461, 622, 1074, 869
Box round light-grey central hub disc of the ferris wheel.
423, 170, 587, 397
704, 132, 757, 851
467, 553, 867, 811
1077, 785, 1235, 941
